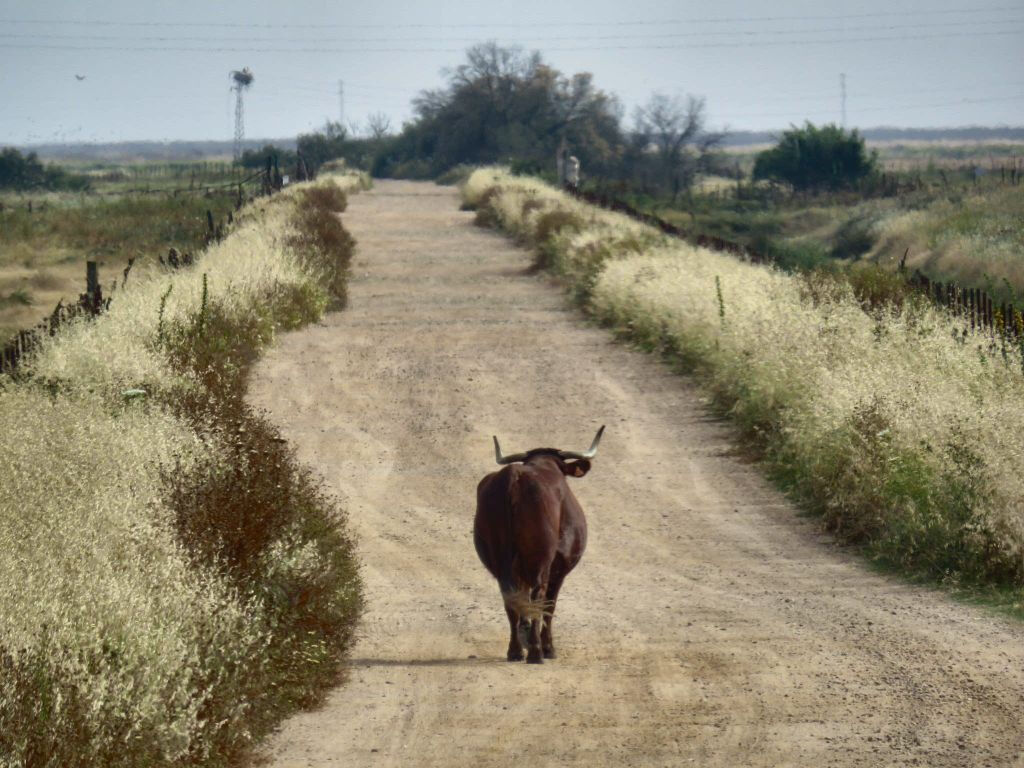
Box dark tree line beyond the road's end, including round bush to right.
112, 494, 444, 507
268, 42, 874, 195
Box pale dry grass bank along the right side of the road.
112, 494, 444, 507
463, 169, 1024, 608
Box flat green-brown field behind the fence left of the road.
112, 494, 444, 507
0, 163, 245, 344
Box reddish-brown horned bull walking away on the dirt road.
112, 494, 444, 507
473, 426, 604, 664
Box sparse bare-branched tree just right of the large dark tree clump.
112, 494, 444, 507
633, 92, 724, 200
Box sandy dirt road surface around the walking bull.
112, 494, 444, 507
252, 182, 1024, 768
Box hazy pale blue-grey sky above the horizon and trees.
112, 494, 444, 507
0, 0, 1024, 144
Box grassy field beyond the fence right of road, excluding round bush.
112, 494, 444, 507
632, 142, 1024, 303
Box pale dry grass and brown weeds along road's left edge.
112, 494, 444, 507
0, 176, 365, 766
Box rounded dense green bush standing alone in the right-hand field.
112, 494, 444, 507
754, 122, 878, 189
